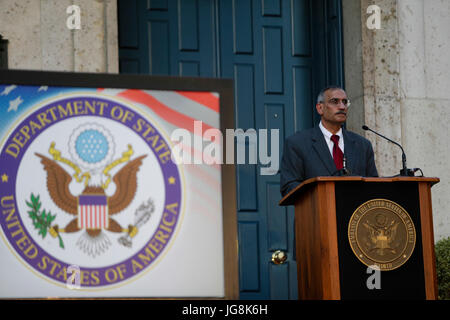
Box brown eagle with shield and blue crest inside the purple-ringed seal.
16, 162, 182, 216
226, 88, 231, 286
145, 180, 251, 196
35, 124, 154, 257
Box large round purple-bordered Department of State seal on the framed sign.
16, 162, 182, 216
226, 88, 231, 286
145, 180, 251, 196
0, 94, 183, 289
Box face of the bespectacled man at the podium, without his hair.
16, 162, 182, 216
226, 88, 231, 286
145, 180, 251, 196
316, 89, 348, 125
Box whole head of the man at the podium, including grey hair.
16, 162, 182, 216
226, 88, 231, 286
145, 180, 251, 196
316, 86, 350, 131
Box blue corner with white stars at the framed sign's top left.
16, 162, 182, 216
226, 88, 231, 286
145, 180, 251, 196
0, 83, 97, 140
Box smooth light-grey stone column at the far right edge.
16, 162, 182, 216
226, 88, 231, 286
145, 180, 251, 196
398, 0, 450, 239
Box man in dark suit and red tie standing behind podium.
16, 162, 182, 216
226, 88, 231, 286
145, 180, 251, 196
280, 86, 378, 196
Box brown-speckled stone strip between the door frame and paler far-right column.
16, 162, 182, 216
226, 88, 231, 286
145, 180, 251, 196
361, 0, 403, 176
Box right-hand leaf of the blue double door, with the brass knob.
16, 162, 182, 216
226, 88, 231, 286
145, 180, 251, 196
219, 0, 313, 299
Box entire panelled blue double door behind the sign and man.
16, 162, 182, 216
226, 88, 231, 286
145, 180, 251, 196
119, 0, 343, 299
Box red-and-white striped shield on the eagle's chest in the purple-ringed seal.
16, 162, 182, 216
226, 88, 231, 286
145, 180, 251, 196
78, 195, 109, 229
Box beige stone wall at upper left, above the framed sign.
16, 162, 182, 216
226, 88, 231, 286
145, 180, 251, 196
0, 0, 119, 73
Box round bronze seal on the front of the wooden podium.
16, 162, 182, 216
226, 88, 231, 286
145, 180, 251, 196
348, 199, 416, 271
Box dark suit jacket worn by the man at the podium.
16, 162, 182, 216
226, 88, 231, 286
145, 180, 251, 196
280, 126, 378, 196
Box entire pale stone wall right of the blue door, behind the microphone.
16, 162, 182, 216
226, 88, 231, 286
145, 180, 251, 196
343, 0, 450, 240
